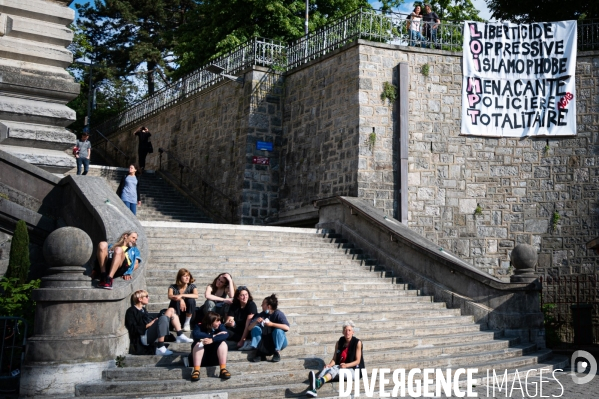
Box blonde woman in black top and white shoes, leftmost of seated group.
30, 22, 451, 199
125, 290, 193, 356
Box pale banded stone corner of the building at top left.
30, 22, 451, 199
0, 0, 79, 172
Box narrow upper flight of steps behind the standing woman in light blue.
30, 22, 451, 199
66, 165, 211, 223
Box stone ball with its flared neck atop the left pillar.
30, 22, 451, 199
42, 227, 94, 288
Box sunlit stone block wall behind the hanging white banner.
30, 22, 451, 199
359, 44, 599, 276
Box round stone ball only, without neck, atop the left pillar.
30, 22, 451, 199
44, 227, 93, 267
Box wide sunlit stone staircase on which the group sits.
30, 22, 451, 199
76, 221, 564, 399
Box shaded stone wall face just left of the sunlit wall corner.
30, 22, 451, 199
279, 46, 365, 212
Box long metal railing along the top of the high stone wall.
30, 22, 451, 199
96, 9, 599, 134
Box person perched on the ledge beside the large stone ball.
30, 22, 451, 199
96, 231, 141, 290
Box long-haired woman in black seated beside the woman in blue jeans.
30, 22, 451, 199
225, 285, 258, 350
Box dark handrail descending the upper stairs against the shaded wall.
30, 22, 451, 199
158, 148, 239, 223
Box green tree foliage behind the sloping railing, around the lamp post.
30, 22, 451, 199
175, 0, 372, 76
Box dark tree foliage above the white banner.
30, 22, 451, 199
485, 0, 599, 23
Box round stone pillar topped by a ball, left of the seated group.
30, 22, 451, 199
21, 227, 130, 397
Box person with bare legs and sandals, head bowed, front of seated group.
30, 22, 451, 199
190, 312, 231, 382
